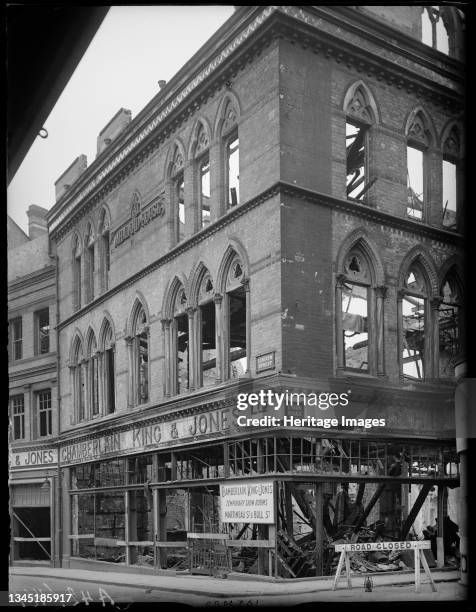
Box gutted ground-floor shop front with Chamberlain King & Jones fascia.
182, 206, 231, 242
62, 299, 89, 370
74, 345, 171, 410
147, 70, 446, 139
60, 410, 459, 578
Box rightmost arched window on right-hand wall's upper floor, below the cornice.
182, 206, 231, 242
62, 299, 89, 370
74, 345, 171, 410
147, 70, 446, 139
442, 127, 461, 229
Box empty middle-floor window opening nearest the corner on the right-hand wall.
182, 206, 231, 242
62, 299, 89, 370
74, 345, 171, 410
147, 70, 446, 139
342, 280, 369, 370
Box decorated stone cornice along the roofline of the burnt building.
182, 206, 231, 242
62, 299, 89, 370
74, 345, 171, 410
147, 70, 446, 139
48, 6, 462, 239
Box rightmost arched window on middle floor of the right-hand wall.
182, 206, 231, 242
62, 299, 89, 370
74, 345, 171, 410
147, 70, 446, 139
438, 274, 462, 378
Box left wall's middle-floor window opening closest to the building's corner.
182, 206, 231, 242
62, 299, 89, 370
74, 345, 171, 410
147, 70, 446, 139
228, 286, 247, 378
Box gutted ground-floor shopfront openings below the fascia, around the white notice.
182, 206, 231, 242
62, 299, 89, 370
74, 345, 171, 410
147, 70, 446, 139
65, 435, 458, 578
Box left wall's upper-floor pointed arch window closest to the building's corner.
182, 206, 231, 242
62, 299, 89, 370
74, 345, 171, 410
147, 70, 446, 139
222, 101, 240, 208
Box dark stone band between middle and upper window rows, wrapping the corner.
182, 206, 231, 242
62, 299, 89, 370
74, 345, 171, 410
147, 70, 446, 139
54, 181, 464, 330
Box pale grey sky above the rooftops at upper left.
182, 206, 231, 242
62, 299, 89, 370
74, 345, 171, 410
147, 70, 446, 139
7, 6, 233, 232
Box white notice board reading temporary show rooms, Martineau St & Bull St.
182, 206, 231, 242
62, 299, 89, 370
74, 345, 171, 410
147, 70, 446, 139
220, 480, 275, 524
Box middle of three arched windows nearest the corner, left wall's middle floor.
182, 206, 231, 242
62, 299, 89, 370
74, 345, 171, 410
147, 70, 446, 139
199, 274, 217, 387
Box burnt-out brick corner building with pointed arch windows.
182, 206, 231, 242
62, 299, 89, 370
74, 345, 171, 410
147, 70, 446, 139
48, 6, 464, 577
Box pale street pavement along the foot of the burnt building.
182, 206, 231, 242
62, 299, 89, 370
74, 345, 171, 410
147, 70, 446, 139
10, 566, 464, 600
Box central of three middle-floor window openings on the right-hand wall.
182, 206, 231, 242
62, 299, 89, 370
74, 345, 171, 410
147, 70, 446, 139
402, 292, 426, 380
